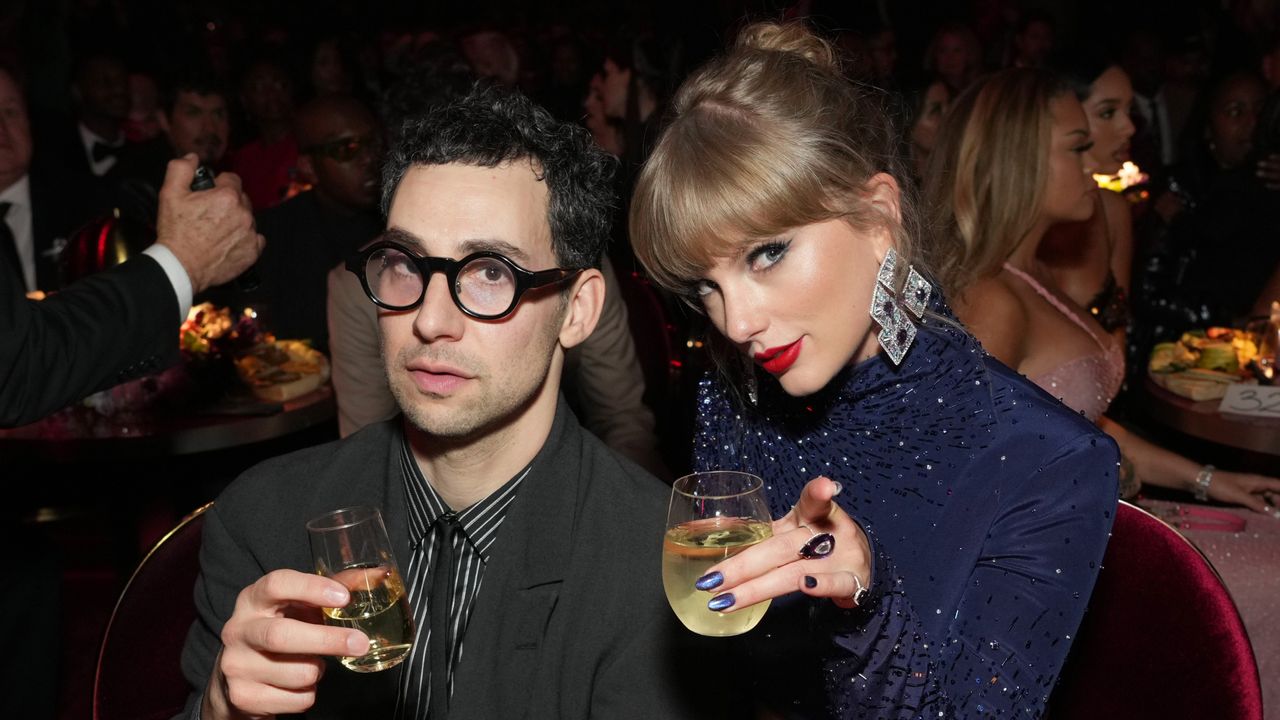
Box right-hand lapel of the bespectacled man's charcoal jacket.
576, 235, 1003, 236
449, 398, 581, 720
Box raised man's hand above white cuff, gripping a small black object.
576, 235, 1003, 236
156, 154, 265, 292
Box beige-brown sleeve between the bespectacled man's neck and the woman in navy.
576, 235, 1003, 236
567, 259, 667, 477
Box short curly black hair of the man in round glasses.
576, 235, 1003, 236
381, 83, 616, 268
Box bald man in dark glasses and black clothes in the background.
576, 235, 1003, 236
233, 95, 383, 348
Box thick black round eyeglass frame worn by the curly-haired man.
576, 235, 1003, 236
346, 240, 586, 320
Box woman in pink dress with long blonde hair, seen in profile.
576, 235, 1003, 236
925, 69, 1280, 512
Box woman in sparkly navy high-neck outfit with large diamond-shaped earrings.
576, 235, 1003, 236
631, 24, 1116, 717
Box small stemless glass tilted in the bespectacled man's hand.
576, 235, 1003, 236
307, 507, 413, 673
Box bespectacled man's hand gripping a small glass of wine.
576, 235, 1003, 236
199, 568, 369, 720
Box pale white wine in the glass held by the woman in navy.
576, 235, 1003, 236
662, 518, 773, 635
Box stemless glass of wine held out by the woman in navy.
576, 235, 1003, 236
662, 470, 773, 637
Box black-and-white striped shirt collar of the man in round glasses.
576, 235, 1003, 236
401, 436, 532, 562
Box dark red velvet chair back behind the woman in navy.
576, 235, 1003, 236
1046, 502, 1262, 720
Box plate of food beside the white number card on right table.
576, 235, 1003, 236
1147, 328, 1258, 400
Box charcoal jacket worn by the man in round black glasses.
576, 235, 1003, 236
179, 400, 732, 720
